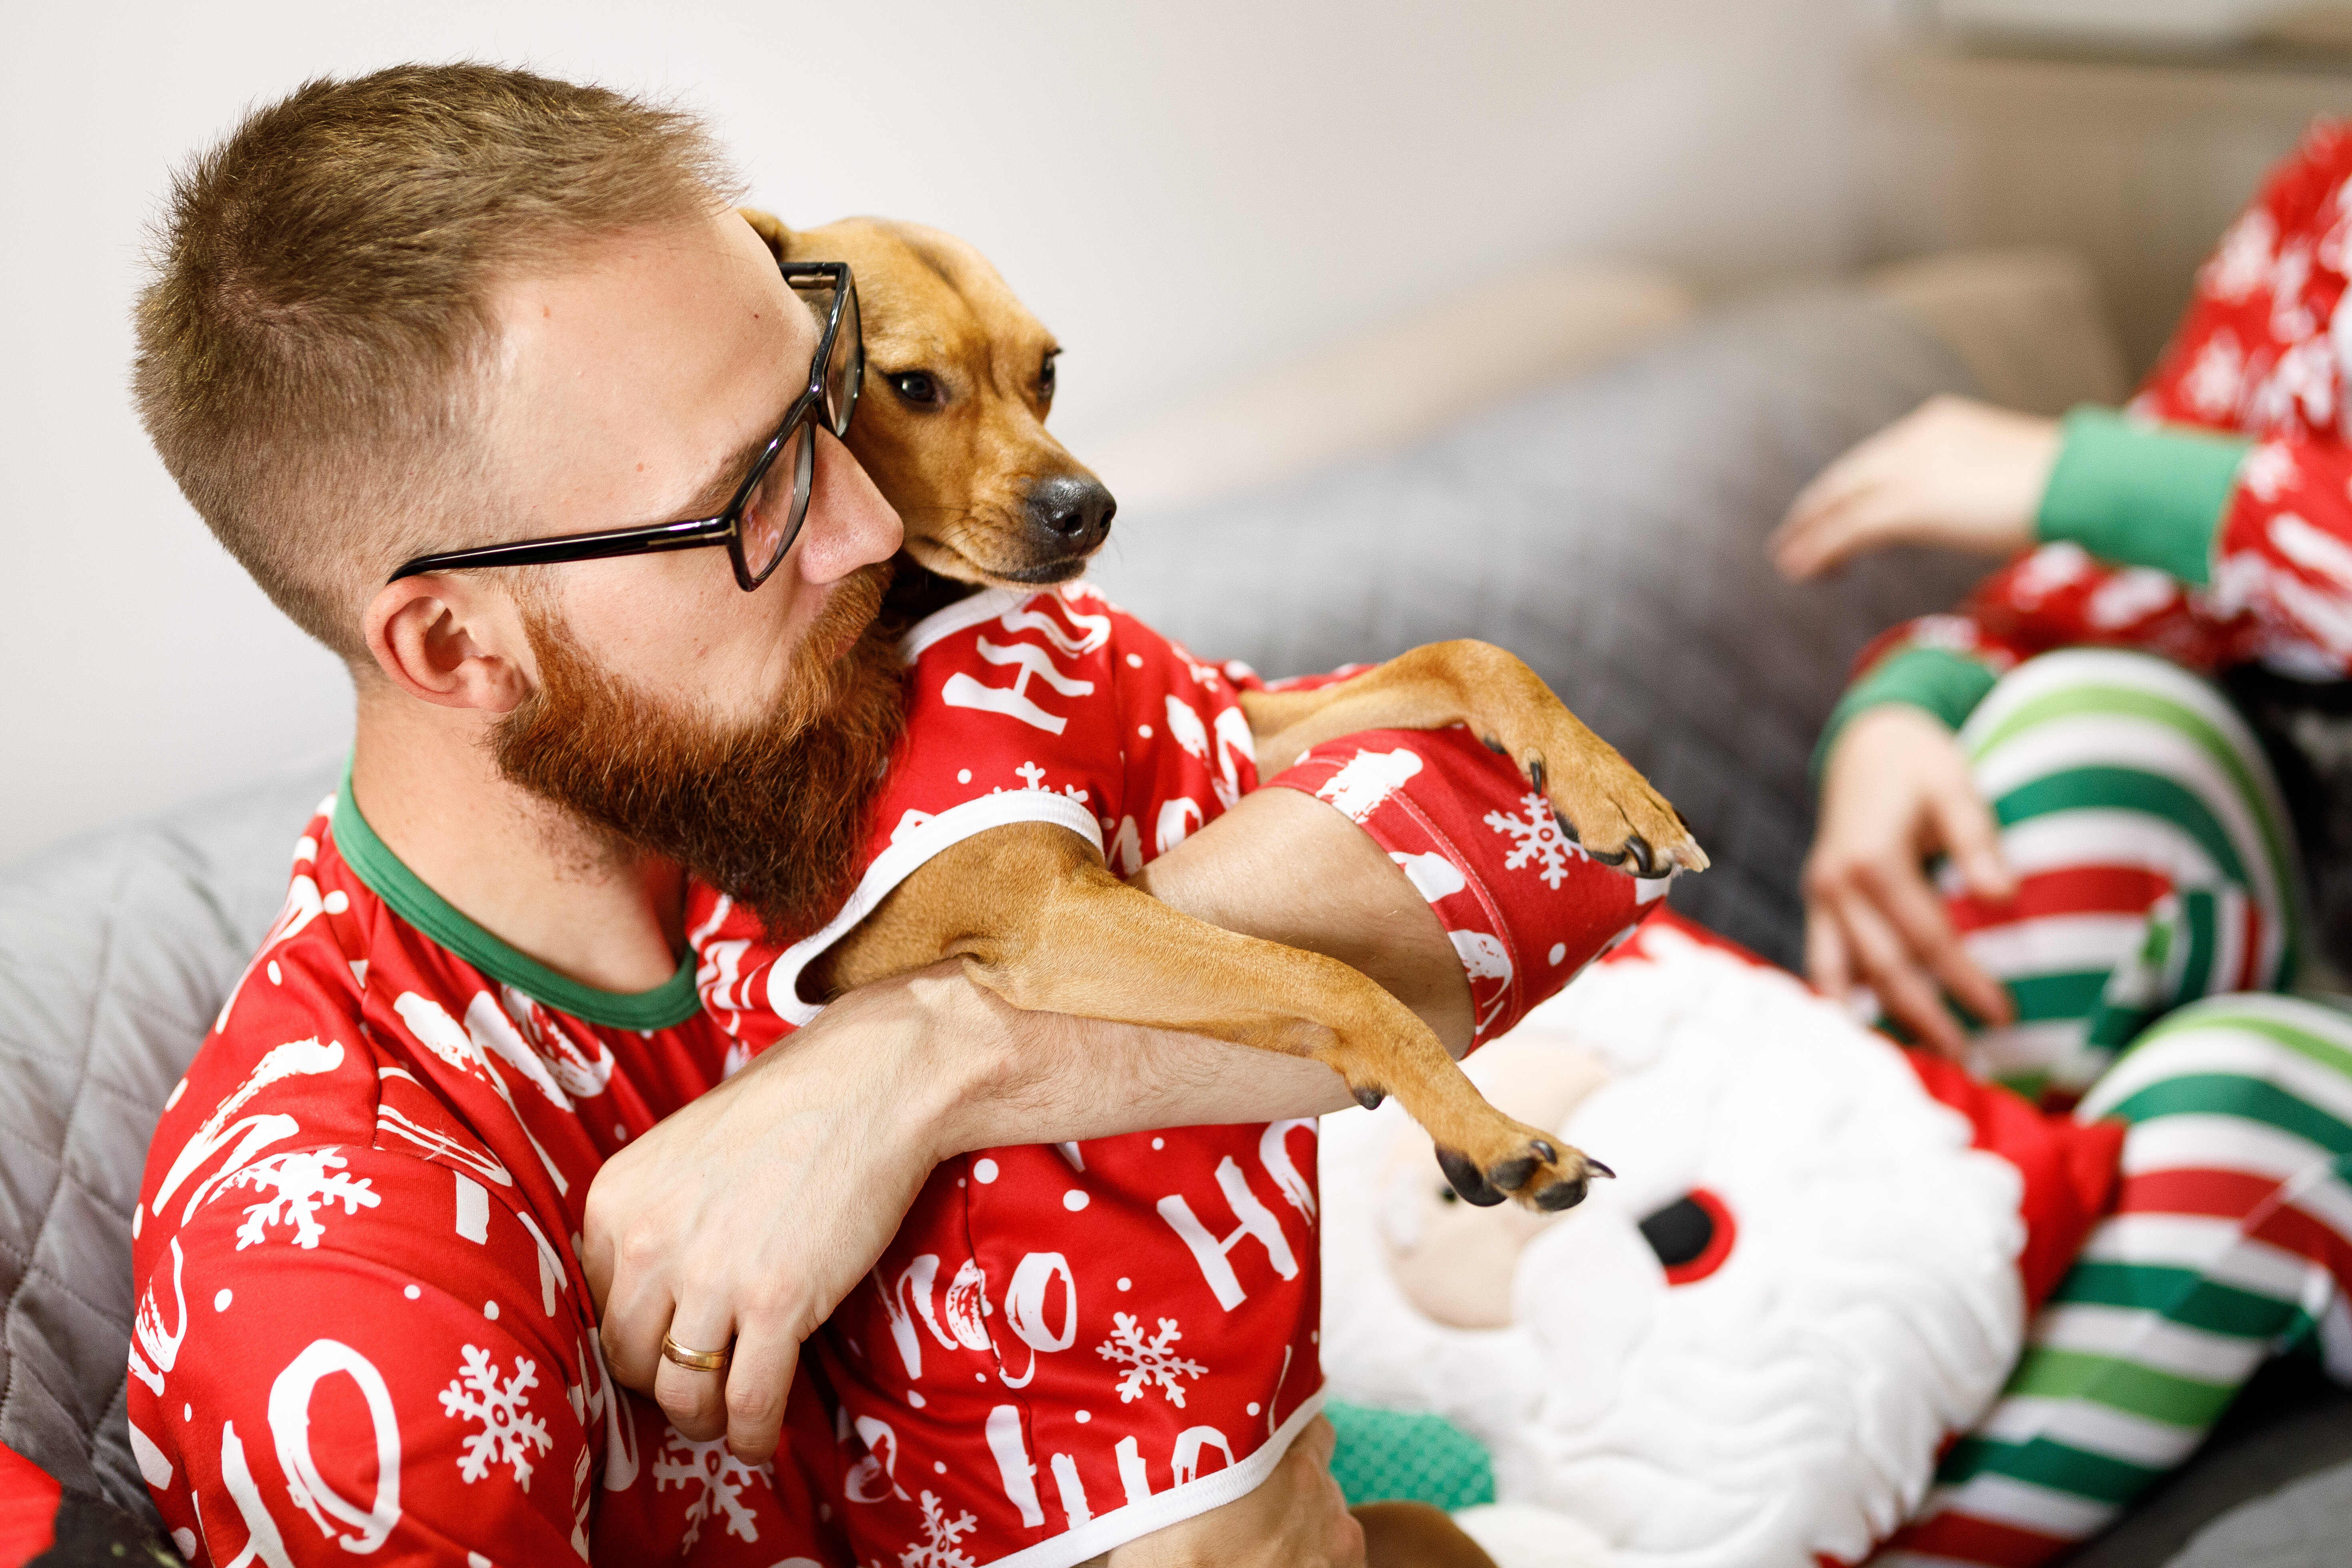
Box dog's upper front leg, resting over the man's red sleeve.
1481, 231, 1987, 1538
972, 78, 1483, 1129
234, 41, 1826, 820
1242, 642, 1707, 877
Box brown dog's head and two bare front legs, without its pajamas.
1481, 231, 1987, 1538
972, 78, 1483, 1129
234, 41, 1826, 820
746, 212, 1707, 1208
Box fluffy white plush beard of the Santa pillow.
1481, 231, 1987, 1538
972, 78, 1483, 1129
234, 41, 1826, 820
1322, 929, 2025, 1568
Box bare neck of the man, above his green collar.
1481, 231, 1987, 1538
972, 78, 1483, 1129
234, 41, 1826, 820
350, 689, 685, 992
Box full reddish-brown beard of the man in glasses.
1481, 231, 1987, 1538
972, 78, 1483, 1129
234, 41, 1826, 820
491, 567, 906, 940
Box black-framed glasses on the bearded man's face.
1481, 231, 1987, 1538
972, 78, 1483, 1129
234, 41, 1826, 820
388, 261, 866, 592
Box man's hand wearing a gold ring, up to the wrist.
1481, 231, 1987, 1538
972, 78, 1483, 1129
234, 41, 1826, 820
581, 966, 1002, 1464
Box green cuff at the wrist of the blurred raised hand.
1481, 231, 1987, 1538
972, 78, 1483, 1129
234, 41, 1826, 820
2035, 404, 2253, 588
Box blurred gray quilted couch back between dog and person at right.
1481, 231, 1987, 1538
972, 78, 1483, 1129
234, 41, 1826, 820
1096, 294, 1985, 964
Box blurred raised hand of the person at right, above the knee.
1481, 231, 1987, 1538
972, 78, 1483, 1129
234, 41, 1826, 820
1764, 397, 2058, 583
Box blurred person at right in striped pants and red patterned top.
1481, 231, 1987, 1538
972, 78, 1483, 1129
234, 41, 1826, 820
1771, 120, 2352, 1568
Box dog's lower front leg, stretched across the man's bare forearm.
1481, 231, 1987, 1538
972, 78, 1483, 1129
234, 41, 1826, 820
821, 823, 1606, 1208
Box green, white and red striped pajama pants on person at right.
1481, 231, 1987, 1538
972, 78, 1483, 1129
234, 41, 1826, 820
1875, 649, 2352, 1568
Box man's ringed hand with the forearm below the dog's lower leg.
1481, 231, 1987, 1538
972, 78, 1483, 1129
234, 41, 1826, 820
581, 964, 1352, 1464
